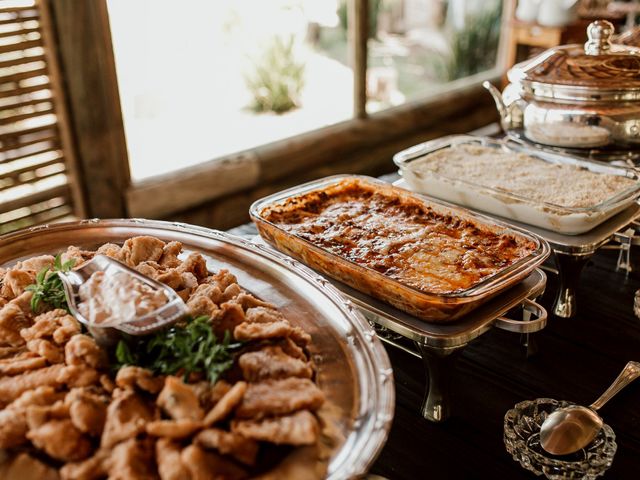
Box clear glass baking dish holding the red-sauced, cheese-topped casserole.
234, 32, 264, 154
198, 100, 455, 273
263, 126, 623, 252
249, 175, 550, 323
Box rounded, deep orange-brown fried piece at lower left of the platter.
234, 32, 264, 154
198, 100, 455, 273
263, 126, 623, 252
27, 419, 92, 462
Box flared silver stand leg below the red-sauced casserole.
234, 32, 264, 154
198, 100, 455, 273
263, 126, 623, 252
416, 342, 465, 422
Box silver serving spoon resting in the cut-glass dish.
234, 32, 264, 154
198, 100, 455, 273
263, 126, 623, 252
540, 362, 640, 455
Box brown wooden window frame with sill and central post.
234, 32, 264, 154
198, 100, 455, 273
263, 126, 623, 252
46, 0, 509, 218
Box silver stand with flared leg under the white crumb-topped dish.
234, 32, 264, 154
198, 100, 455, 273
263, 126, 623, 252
393, 179, 640, 318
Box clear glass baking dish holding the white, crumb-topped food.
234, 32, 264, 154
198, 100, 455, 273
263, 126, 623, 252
393, 135, 640, 235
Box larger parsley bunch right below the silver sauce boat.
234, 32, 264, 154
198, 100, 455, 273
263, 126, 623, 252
115, 316, 241, 383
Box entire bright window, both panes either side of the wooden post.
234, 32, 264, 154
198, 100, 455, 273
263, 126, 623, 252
107, 0, 501, 184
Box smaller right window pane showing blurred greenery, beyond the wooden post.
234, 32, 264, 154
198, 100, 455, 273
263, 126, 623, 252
367, 0, 502, 112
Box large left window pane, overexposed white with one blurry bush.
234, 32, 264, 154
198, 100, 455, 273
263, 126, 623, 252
108, 0, 353, 181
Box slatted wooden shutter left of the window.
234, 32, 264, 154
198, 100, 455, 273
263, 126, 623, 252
0, 0, 84, 234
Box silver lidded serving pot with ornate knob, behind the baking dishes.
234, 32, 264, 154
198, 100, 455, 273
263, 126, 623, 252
484, 20, 640, 149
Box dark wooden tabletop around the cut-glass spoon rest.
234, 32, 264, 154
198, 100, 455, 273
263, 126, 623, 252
232, 203, 640, 480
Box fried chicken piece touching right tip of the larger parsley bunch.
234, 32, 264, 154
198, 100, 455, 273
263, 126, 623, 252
238, 346, 313, 382
